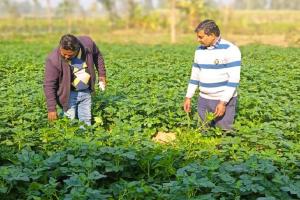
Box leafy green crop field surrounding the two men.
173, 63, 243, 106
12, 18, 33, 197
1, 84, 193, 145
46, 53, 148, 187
0, 37, 300, 200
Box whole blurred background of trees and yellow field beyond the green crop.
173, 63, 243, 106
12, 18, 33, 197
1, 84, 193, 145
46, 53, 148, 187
0, 0, 300, 46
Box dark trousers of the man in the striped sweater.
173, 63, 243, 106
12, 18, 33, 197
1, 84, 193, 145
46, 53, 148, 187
198, 96, 237, 130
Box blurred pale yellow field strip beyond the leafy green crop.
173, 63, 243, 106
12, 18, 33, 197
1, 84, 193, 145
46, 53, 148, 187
0, 10, 300, 46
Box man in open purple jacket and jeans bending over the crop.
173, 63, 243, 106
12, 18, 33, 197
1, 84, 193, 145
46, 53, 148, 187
44, 34, 106, 125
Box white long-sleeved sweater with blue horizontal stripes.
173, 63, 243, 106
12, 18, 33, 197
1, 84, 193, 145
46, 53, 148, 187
186, 38, 241, 102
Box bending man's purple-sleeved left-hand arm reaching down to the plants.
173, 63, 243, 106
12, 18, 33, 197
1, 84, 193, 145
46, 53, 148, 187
44, 59, 59, 121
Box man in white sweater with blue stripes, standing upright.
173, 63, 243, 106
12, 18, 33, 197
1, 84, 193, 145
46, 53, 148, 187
184, 19, 241, 130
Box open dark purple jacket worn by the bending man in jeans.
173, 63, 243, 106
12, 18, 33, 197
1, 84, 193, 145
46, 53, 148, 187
44, 36, 106, 112
